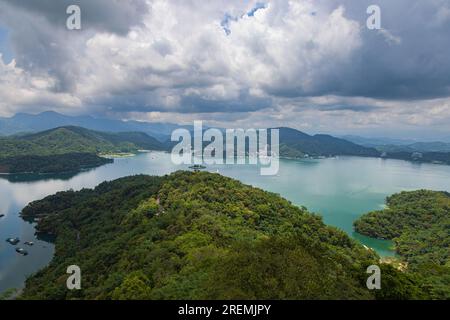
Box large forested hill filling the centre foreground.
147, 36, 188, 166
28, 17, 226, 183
22, 172, 422, 299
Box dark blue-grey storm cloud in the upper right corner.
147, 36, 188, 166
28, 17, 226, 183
329, 0, 450, 99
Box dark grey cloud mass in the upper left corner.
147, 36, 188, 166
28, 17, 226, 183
0, 0, 147, 92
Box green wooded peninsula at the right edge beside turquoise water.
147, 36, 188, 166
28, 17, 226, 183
355, 190, 450, 299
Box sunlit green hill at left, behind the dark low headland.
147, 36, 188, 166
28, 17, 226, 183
0, 127, 164, 158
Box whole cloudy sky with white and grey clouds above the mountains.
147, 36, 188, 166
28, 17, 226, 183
0, 0, 450, 140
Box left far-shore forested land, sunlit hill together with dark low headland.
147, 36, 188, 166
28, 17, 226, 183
0, 127, 164, 174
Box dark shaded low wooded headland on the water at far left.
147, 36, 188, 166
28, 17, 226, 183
0, 153, 113, 174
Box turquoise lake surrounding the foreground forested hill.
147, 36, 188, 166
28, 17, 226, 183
0, 152, 450, 292
